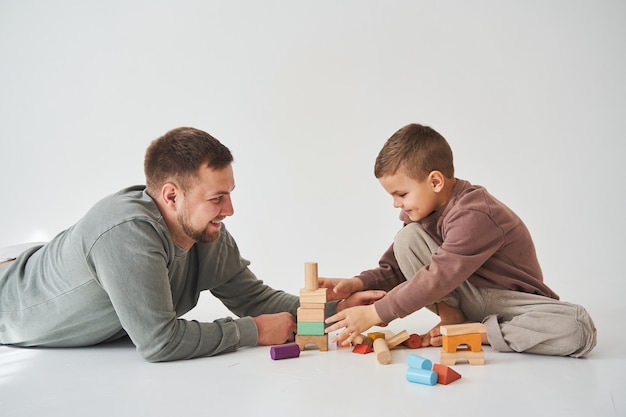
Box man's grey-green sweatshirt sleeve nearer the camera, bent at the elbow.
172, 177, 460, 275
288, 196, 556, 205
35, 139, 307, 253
87, 222, 296, 362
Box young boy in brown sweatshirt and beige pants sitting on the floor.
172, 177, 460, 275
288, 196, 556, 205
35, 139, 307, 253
320, 124, 596, 357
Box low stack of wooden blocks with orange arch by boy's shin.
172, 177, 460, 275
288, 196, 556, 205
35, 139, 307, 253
440, 323, 487, 365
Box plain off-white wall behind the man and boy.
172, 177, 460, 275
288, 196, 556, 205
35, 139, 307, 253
0, 0, 626, 316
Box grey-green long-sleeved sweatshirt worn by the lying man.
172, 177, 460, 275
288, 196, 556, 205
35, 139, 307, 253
0, 186, 299, 362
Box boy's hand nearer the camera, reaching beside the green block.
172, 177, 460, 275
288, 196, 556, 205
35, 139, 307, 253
326, 304, 382, 346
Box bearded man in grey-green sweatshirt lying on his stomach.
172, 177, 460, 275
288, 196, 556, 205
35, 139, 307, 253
0, 127, 379, 362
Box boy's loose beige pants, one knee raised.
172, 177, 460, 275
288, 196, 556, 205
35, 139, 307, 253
394, 223, 597, 357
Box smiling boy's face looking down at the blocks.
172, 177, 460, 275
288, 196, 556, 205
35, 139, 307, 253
378, 171, 445, 221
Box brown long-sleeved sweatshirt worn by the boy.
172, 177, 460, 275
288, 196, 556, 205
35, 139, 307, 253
359, 179, 559, 323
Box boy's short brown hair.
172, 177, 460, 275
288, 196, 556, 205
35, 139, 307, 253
374, 123, 454, 181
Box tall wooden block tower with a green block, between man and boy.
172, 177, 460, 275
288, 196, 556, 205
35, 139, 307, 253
296, 262, 328, 351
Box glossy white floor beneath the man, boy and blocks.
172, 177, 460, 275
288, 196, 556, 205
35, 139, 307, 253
0, 302, 626, 417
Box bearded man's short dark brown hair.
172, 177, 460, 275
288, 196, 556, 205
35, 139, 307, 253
144, 127, 233, 195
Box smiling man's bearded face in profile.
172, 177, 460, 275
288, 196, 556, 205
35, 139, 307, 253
177, 165, 235, 242
